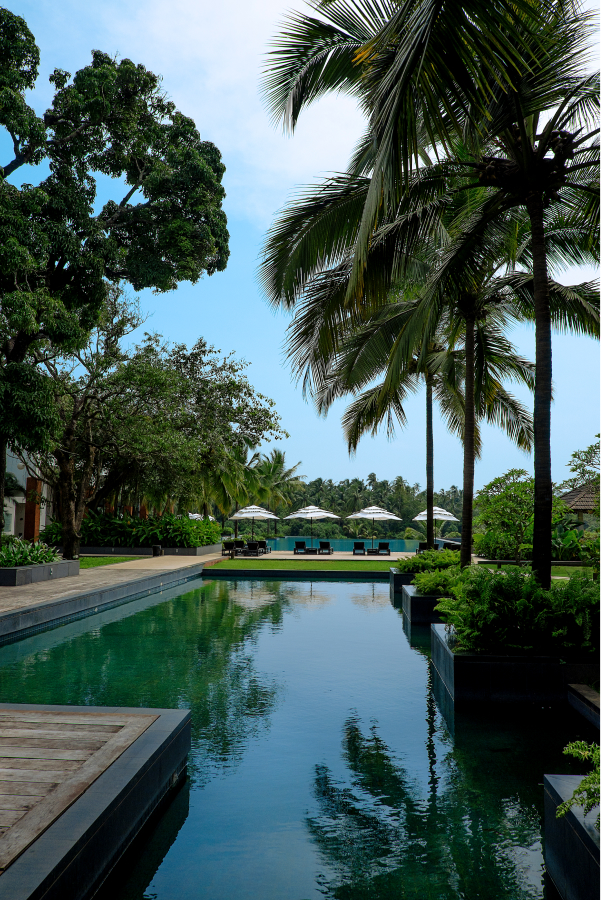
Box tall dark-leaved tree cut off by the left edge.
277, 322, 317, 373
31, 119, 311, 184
0, 9, 229, 540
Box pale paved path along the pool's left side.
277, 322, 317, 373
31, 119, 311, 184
0, 556, 215, 614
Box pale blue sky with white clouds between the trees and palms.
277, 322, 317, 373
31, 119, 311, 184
0, 0, 599, 490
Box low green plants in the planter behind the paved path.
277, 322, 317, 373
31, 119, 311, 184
40, 512, 221, 547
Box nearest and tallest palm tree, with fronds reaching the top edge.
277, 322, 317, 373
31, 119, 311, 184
262, 0, 599, 585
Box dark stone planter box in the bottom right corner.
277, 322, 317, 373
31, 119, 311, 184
544, 775, 599, 900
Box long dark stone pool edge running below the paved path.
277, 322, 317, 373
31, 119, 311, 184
0, 563, 204, 646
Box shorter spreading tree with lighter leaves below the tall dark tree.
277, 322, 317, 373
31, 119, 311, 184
24, 292, 282, 559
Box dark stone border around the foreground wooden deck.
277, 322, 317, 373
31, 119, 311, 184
0, 703, 191, 900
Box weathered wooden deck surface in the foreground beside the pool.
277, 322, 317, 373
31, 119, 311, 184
0, 707, 158, 871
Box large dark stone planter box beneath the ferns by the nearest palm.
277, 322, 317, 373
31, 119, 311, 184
431, 625, 598, 704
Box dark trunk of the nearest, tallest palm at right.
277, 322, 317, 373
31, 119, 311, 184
526, 194, 553, 589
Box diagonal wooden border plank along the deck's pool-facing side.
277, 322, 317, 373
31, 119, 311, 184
0, 715, 158, 870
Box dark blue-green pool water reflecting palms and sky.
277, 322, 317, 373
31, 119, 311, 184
0, 578, 593, 900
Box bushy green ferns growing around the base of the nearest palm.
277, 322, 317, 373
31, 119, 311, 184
436, 566, 599, 658
